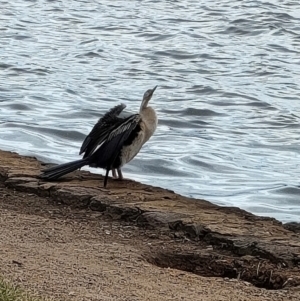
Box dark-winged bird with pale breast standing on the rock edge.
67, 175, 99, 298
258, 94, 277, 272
39, 86, 158, 187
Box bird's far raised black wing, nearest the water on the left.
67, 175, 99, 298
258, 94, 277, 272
79, 104, 126, 158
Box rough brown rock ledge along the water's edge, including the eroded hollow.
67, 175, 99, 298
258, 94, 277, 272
0, 151, 300, 289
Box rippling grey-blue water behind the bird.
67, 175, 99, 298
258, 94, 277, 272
0, 0, 300, 222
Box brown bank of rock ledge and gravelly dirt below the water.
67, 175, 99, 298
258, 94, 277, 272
0, 152, 300, 300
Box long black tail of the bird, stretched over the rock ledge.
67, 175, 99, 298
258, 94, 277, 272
39, 159, 88, 180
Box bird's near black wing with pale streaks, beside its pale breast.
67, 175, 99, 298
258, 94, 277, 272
90, 114, 141, 169
